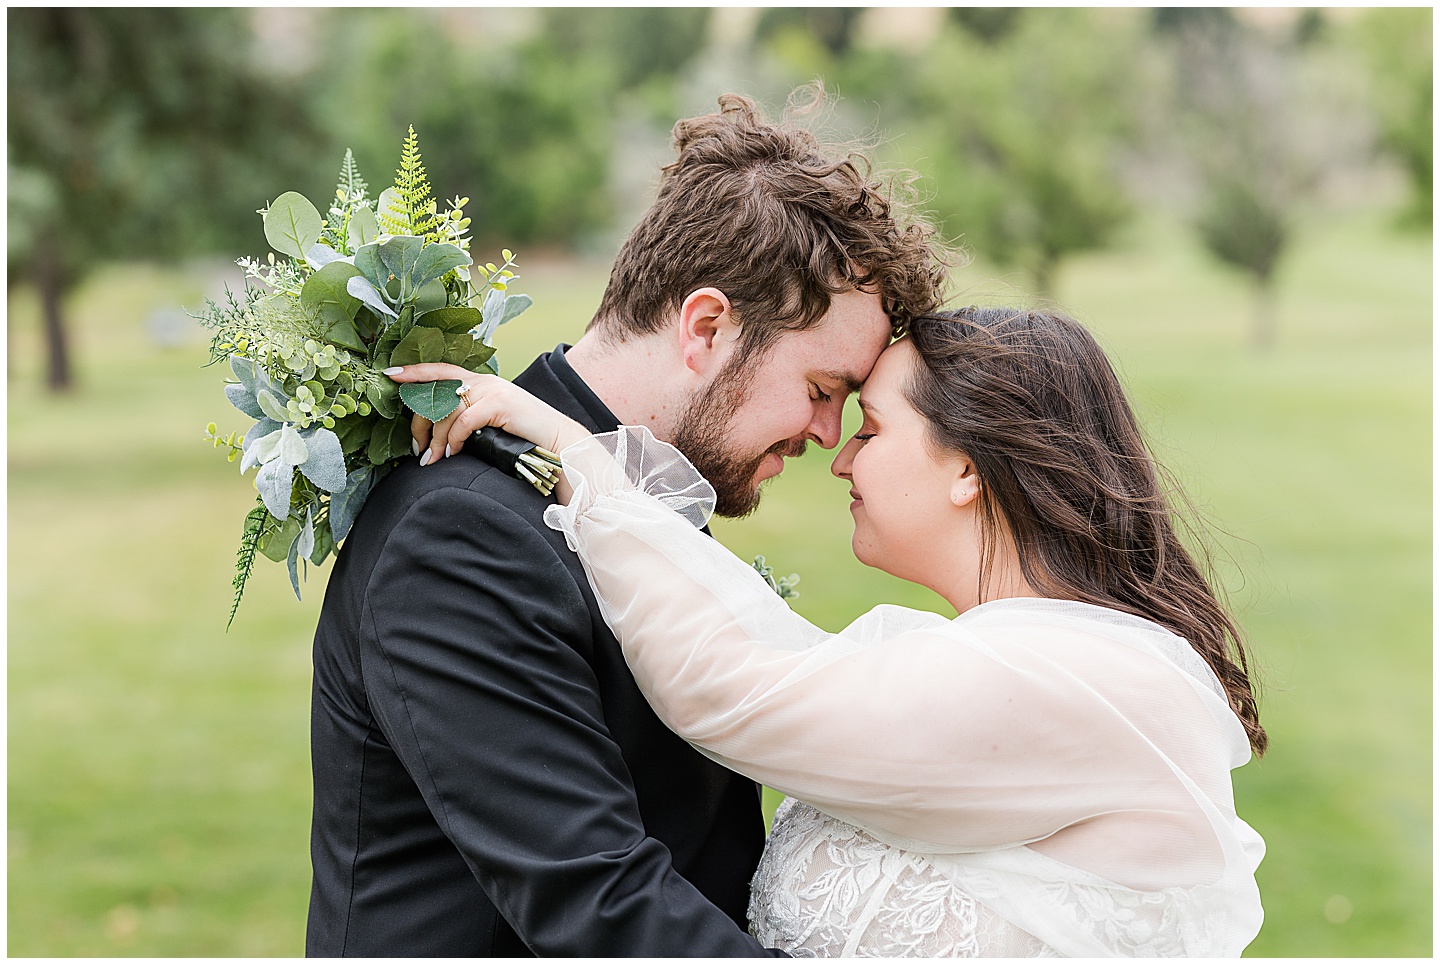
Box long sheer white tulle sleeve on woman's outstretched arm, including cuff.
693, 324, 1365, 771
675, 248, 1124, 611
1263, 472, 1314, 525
546, 428, 1248, 869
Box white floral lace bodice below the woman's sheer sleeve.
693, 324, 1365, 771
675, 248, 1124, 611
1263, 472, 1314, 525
750, 798, 1054, 958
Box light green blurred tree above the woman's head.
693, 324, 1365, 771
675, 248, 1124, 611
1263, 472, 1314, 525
847, 9, 1140, 294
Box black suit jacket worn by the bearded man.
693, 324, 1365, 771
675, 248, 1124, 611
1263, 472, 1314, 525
305, 346, 768, 956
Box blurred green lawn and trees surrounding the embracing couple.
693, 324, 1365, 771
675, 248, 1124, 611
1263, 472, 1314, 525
6, 7, 1433, 956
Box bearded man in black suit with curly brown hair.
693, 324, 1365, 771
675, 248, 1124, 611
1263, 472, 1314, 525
305, 95, 940, 956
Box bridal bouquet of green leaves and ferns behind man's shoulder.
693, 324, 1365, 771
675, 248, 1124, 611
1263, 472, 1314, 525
196, 128, 557, 625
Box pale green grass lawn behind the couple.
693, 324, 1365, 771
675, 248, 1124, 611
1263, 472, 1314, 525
9, 207, 1431, 956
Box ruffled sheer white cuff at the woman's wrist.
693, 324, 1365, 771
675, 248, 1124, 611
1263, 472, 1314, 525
544, 425, 716, 550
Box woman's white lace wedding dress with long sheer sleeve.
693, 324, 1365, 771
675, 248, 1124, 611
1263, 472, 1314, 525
546, 428, 1264, 958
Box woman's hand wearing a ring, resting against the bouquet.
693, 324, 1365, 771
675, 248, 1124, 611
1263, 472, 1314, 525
384, 362, 590, 465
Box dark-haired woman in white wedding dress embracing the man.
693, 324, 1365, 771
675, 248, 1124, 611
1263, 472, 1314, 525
388, 308, 1266, 956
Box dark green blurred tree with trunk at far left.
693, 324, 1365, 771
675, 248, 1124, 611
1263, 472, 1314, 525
6, 7, 312, 390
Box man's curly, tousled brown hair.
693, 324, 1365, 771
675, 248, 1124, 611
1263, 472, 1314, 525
590, 85, 948, 357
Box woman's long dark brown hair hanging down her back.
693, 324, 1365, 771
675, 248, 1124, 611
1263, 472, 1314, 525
906, 307, 1269, 755
